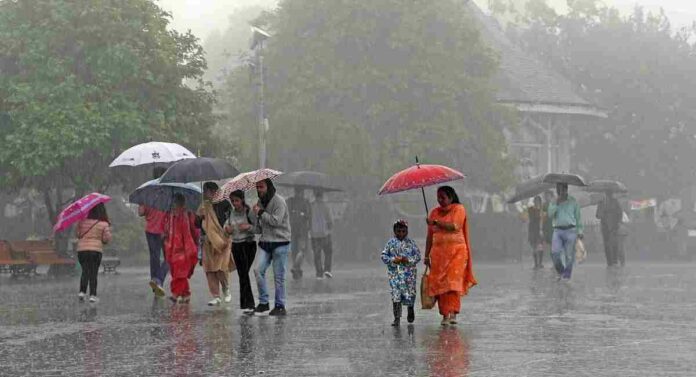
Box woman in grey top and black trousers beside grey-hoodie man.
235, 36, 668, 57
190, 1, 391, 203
225, 190, 257, 314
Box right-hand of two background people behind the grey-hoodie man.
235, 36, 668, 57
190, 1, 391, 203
310, 190, 333, 279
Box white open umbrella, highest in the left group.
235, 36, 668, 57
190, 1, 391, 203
109, 141, 196, 168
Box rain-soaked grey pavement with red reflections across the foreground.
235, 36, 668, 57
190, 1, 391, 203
0, 264, 696, 376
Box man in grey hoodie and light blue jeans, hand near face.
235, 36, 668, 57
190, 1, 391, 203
253, 179, 291, 316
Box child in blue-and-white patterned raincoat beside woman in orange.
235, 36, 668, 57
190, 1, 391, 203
382, 220, 421, 326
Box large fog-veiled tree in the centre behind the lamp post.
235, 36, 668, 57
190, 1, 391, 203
221, 0, 512, 190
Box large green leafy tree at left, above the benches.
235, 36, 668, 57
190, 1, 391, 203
0, 0, 215, 238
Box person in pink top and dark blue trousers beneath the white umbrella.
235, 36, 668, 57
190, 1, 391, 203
138, 167, 169, 297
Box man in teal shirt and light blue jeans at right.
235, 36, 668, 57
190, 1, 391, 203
548, 183, 583, 280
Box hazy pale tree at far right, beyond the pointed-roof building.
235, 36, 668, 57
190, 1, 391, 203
502, 0, 696, 196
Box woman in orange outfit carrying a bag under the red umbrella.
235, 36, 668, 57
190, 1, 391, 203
425, 186, 477, 326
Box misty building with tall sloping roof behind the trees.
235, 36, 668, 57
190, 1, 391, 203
467, 1, 607, 180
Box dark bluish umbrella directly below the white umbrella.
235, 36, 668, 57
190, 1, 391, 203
128, 179, 202, 211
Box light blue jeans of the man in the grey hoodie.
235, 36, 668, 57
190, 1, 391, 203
254, 244, 290, 308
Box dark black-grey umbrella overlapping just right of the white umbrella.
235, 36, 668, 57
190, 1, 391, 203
160, 157, 239, 183
